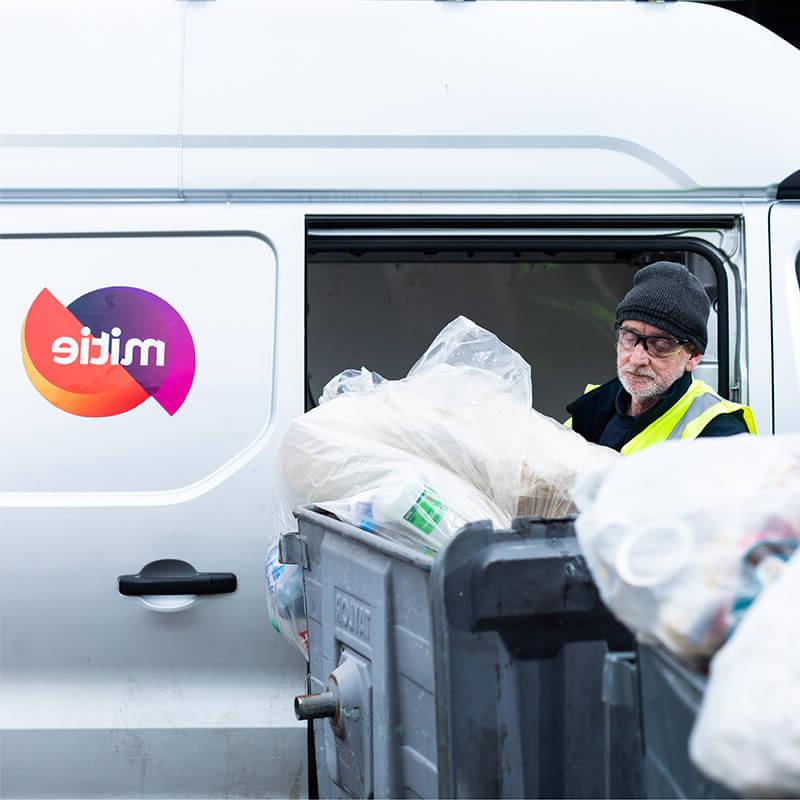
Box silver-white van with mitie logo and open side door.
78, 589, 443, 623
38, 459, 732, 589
0, 0, 800, 798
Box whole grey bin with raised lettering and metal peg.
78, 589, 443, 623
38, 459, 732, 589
281, 508, 641, 798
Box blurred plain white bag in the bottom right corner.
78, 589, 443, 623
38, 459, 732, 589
689, 552, 800, 797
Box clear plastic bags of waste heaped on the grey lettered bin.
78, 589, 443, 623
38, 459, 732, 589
266, 317, 621, 660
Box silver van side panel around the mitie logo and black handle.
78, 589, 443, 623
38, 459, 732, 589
0, 204, 306, 797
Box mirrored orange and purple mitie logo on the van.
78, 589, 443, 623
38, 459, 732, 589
22, 286, 195, 417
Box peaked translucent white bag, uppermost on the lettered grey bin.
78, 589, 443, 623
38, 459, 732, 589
308, 317, 533, 517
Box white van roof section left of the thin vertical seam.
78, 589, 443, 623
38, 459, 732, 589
0, 0, 186, 195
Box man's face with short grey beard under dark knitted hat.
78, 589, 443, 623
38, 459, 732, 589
617, 320, 702, 400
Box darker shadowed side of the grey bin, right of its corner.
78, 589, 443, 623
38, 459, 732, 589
431, 519, 638, 798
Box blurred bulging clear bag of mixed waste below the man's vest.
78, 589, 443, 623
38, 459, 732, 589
575, 434, 800, 666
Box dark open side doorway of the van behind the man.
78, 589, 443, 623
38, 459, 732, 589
306, 221, 728, 419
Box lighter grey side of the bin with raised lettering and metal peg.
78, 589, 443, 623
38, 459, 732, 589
299, 514, 437, 797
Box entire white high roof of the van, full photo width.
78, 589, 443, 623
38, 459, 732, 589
0, 0, 800, 199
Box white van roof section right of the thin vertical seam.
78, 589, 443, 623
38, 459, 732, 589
183, 0, 800, 192
